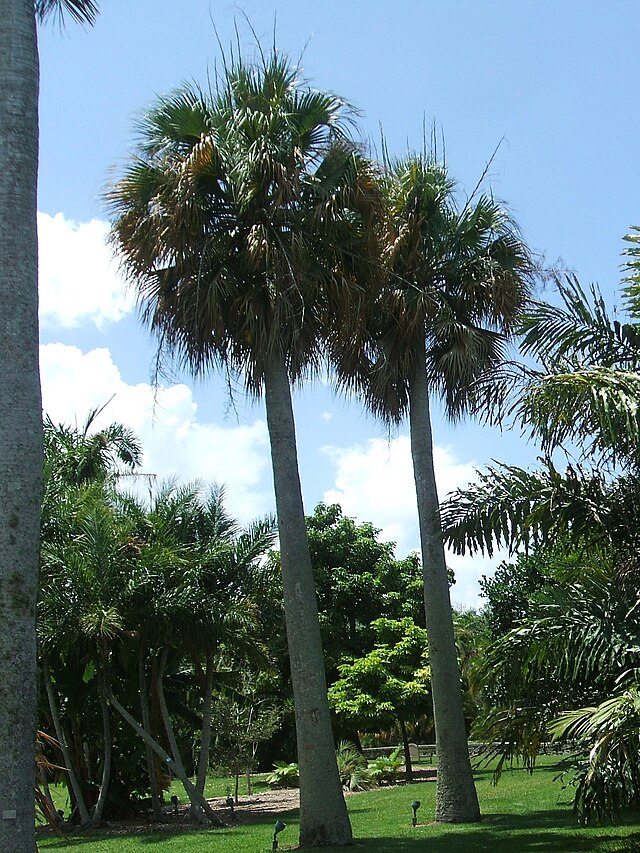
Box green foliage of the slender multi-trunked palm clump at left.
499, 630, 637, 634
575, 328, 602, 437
38, 413, 275, 817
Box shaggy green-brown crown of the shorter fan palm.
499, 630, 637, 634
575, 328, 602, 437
333, 156, 535, 423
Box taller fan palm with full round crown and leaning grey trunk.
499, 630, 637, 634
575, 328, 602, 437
108, 49, 375, 846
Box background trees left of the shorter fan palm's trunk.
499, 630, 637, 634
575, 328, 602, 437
38, 412, 460, 825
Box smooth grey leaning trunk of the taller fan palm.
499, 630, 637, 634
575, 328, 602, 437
264, 358, 352, 847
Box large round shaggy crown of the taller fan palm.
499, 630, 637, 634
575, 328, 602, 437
107, 51, 377, 393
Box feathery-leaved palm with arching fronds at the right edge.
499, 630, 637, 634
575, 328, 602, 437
442, 264, 640, 820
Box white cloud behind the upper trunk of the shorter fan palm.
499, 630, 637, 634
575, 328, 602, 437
322, 435, 502, 607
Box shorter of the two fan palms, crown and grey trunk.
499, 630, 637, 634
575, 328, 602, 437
336, 156, 532, 822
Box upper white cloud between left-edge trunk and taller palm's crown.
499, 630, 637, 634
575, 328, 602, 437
38, 213, 135, 328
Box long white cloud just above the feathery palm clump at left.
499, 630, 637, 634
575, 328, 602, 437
40, 343, 273, 522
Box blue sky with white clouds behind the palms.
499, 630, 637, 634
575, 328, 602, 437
39, 0, 640, 605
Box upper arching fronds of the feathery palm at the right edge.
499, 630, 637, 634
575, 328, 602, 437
442, 277, 640, 562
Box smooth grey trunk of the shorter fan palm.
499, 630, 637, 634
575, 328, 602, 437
409, 344, 480, 823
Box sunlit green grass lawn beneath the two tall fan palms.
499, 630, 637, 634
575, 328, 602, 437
39, 758, 640, 853
